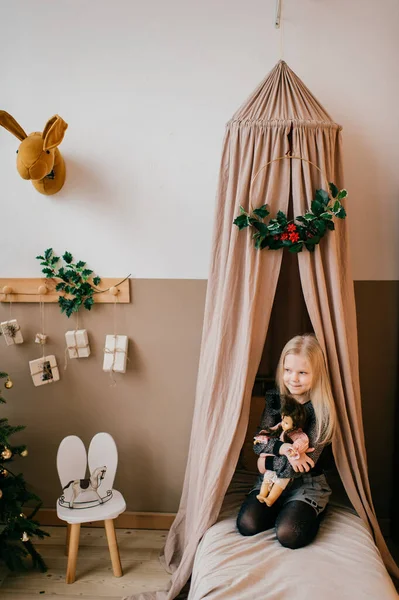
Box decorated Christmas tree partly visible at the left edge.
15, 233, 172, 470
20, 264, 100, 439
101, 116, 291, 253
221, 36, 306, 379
0, 371, 48, 571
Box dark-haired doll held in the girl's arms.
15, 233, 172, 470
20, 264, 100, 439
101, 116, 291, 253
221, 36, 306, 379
254, 396, 309, 506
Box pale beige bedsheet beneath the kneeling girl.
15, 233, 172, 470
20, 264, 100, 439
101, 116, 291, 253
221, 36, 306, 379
188, 476, 399, 600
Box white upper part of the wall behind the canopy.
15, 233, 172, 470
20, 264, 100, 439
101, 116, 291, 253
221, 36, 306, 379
0, 0, 399, 279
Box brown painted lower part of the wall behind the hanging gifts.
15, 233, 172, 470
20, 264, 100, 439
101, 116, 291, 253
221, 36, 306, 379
0, 279, 399, 518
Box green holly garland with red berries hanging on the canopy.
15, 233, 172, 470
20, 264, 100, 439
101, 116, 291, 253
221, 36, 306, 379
233, 183, 348, 253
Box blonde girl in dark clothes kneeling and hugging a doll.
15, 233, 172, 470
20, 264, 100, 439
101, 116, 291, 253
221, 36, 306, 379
237, 334, 336, 548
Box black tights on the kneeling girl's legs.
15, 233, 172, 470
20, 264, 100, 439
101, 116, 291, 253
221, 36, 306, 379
237, 490, 323, 549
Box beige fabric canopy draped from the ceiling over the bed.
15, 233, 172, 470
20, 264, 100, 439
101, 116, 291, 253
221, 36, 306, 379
124, 61, 399, 600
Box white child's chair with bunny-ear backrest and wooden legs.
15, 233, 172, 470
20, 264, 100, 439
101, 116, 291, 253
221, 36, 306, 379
57, 433, 126, 583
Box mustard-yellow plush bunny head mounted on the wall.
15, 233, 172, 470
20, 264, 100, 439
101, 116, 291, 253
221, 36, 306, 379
0, 110, 68, 196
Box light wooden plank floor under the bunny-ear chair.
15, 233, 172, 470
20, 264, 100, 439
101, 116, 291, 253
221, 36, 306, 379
0, 527, 170, 600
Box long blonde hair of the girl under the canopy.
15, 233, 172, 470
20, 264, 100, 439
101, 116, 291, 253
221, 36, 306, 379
276, 333, 337, 444
